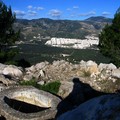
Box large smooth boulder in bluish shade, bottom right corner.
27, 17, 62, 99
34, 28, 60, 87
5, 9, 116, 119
57, 94, 120, 120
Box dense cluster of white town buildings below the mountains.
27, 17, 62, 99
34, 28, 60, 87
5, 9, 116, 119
45, 36, 99, 49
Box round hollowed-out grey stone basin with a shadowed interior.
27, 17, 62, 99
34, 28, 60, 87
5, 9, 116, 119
0, 86, 61, 120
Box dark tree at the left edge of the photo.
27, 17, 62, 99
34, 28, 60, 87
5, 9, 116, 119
0, 2, 19, 63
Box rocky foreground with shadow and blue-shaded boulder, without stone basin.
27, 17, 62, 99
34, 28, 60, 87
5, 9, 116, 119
0, 60, 120, 120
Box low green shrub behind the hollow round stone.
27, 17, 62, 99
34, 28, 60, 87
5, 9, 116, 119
20, 79, 61, 94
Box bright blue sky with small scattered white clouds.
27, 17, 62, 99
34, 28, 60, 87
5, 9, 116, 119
3, 0, 120, 20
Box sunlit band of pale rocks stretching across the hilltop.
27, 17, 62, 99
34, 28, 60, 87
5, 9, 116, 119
0, 60, 120, 94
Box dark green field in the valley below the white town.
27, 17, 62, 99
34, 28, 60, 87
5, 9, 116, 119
16, 42, 110, 64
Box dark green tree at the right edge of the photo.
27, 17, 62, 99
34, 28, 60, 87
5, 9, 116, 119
99, 8, 120, 66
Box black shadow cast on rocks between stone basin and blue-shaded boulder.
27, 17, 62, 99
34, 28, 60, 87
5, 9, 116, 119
56, 78, 107, 118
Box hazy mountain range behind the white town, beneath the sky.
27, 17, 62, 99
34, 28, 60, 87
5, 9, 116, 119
14, 16, 112, 40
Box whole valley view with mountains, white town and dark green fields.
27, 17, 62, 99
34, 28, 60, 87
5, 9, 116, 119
14, 17, 112, 64
